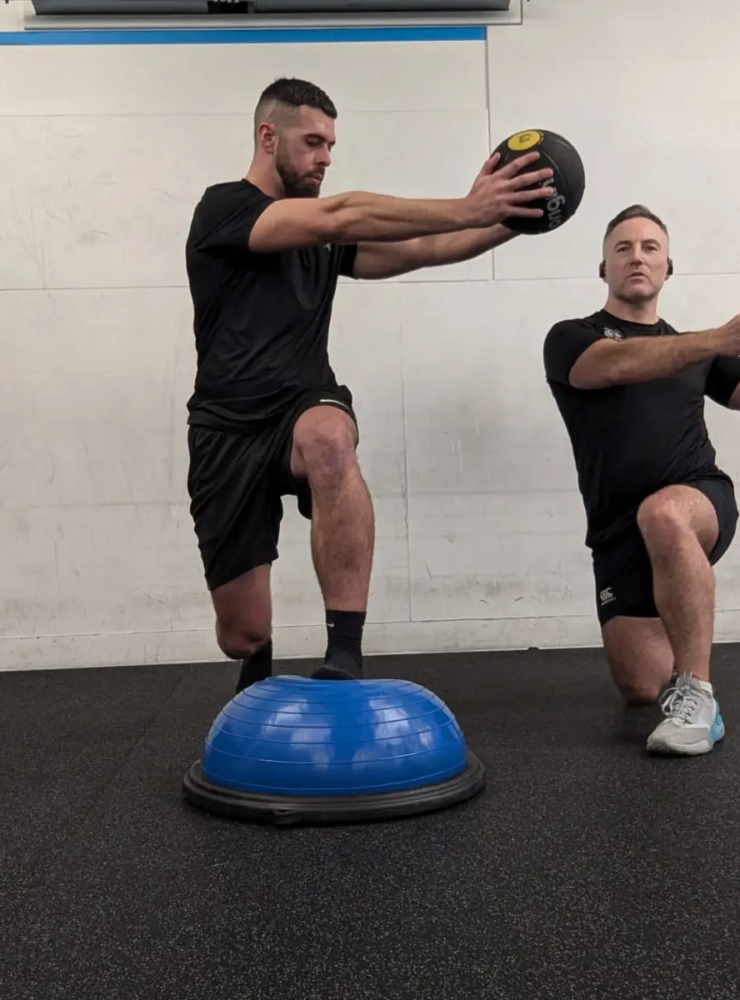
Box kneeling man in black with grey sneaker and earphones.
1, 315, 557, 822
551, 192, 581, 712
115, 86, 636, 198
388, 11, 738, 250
544, 205, 740, 754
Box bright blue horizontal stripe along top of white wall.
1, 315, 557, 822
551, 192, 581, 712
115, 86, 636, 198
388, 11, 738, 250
0, 25, 486, 45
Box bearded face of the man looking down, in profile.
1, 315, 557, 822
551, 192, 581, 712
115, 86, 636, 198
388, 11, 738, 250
274, 107, 336, 198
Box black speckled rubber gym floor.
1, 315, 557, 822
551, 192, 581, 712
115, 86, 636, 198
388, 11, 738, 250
0, 646, 740, 1000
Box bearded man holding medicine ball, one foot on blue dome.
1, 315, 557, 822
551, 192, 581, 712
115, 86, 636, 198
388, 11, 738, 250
186, 79, 553, 691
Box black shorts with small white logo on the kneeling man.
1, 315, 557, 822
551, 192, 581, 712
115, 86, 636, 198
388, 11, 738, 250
593, 475, 738, 626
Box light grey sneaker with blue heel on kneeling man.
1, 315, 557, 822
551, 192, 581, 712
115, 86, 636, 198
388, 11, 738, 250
647, 674, 725, 754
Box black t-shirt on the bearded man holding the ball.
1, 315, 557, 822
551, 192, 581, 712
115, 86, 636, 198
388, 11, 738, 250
186, 180, 357, 431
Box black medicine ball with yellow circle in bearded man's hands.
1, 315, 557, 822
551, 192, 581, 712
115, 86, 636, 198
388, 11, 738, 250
494, 129, 586, 235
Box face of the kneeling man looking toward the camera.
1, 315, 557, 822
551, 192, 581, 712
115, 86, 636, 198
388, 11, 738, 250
604, 219, 668, 305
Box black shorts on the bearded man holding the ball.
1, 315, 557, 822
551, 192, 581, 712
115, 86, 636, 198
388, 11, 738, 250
188, 386, 357, 590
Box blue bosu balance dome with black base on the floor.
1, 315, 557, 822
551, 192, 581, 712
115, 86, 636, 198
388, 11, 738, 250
183, 676, 485, 824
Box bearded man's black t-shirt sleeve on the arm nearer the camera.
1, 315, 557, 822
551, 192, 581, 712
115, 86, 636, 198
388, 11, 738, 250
188, 186, 274, 253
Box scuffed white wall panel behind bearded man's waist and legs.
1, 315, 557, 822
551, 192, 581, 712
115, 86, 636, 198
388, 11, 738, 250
0, 283, 408, 652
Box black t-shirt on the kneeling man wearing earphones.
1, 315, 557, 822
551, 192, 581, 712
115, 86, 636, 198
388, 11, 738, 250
544, 310, 740, 546
